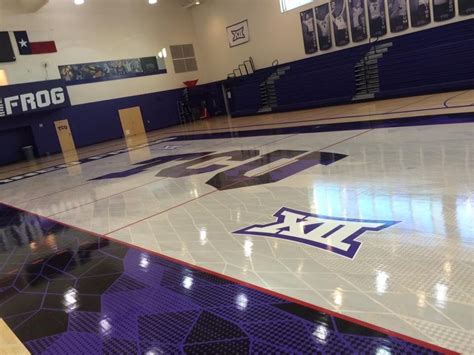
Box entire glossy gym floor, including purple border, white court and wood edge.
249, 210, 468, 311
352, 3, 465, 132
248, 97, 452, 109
0, 90, 474, 354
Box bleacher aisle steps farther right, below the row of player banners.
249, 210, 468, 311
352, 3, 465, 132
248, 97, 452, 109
352, 42, 392, 101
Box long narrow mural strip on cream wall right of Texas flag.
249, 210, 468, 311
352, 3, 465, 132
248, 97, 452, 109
58, 57, 166, 85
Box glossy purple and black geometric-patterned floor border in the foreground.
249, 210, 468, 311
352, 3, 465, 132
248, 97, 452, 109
0, 204, 454, 355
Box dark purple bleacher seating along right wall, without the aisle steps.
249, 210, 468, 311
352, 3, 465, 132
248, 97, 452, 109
225, 19, 474, 116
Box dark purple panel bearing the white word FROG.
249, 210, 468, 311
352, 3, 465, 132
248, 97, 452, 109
0, 80, 71, 118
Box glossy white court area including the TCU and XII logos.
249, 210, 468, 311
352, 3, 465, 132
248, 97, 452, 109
0, 116, 474, 354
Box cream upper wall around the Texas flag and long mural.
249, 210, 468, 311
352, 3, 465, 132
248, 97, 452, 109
0, 0, 203, 105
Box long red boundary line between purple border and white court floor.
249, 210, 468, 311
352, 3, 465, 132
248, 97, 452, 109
2, 202, 459, 355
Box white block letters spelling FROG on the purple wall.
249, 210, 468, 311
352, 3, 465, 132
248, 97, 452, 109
0, 87, 66, 117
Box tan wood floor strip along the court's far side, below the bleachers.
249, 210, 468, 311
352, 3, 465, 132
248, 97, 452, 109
0, 90, 474, 179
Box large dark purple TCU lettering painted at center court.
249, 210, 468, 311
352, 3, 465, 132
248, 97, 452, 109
92, 149, 346, 190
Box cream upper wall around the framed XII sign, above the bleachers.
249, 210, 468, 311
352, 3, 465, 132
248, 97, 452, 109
192, 0, 474, 82
